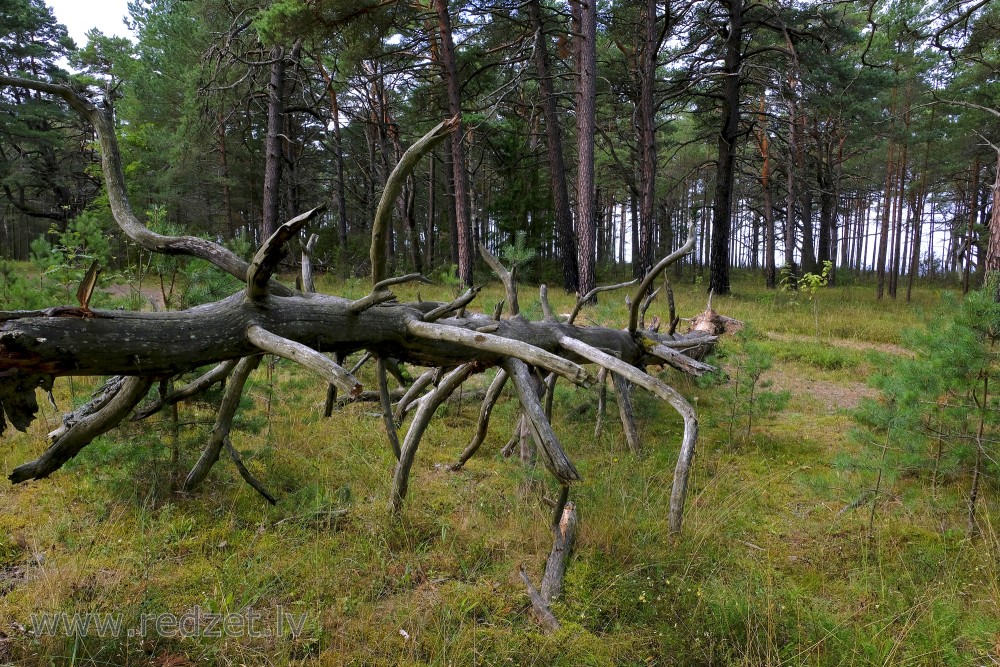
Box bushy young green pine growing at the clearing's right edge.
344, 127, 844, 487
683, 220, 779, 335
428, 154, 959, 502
855, 275, 1000, 534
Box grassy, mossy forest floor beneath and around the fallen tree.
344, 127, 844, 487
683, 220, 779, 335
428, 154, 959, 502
0, 272, 1000, 667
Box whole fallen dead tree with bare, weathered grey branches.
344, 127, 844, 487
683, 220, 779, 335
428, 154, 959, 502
0, 76, 728, 622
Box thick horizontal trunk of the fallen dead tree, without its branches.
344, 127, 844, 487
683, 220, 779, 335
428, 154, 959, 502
0, 293, 696, 383
